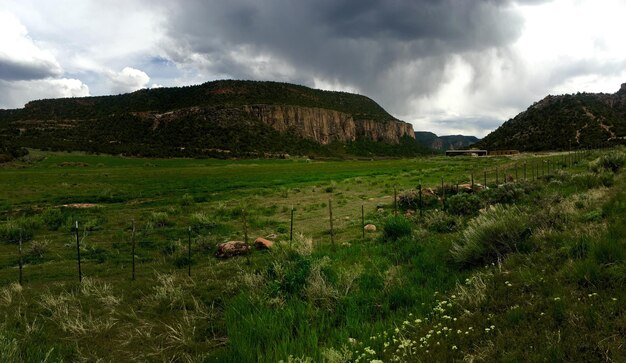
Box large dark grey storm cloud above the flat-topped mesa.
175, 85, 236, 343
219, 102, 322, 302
165, 0, 522, 112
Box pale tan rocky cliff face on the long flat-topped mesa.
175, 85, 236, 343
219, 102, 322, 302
243, 105, 415, 145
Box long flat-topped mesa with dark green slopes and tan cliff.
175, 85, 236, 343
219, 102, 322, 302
0, 81, 425, 157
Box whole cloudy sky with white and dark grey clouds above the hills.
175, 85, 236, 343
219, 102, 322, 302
0, 0, 626, 137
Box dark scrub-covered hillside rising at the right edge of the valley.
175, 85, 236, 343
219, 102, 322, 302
475, 83, 626, 151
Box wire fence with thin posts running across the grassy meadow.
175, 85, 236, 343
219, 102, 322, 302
0, 149, 606, 285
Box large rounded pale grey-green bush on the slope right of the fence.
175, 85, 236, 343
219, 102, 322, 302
450, 205, 531, 266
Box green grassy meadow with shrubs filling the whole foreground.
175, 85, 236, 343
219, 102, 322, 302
0, 150, 626, 362
